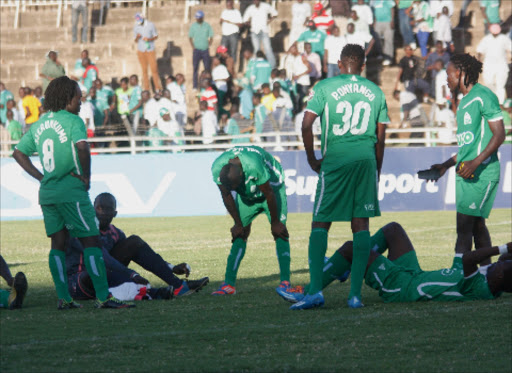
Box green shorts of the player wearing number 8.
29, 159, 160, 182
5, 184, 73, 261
41, 197, 100, 237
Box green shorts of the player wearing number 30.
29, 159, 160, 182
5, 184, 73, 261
313, 159, 380, 222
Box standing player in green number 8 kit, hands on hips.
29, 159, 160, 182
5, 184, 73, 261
13, 76, 133, 310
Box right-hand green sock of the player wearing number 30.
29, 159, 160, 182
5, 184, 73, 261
348, 231, 370, 299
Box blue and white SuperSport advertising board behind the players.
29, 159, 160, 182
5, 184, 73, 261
0, 145, 512, 220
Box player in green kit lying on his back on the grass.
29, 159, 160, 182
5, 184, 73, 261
278, 223, 512, 303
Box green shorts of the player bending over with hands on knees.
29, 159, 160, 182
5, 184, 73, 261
236, 184, 288, 227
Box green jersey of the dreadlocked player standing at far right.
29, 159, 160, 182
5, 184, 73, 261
457, 83, 503, 180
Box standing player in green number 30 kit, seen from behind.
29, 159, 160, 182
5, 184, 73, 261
291, 44, 389, 309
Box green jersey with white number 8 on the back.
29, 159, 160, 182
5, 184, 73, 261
16, 110, 88, 205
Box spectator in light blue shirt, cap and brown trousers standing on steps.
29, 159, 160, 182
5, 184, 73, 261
188, 10, 213, 89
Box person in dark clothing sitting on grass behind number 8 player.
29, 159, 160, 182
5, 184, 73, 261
67, 193, 209, 300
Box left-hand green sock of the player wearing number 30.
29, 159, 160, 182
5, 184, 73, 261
308, 228, 328, 295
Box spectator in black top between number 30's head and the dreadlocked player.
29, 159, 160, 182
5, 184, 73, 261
395, 45, 430, 101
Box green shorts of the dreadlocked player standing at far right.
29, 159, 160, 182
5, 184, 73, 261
455, 175, 498, 218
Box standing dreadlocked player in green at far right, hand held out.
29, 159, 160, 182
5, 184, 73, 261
426, 53, 505, 263
